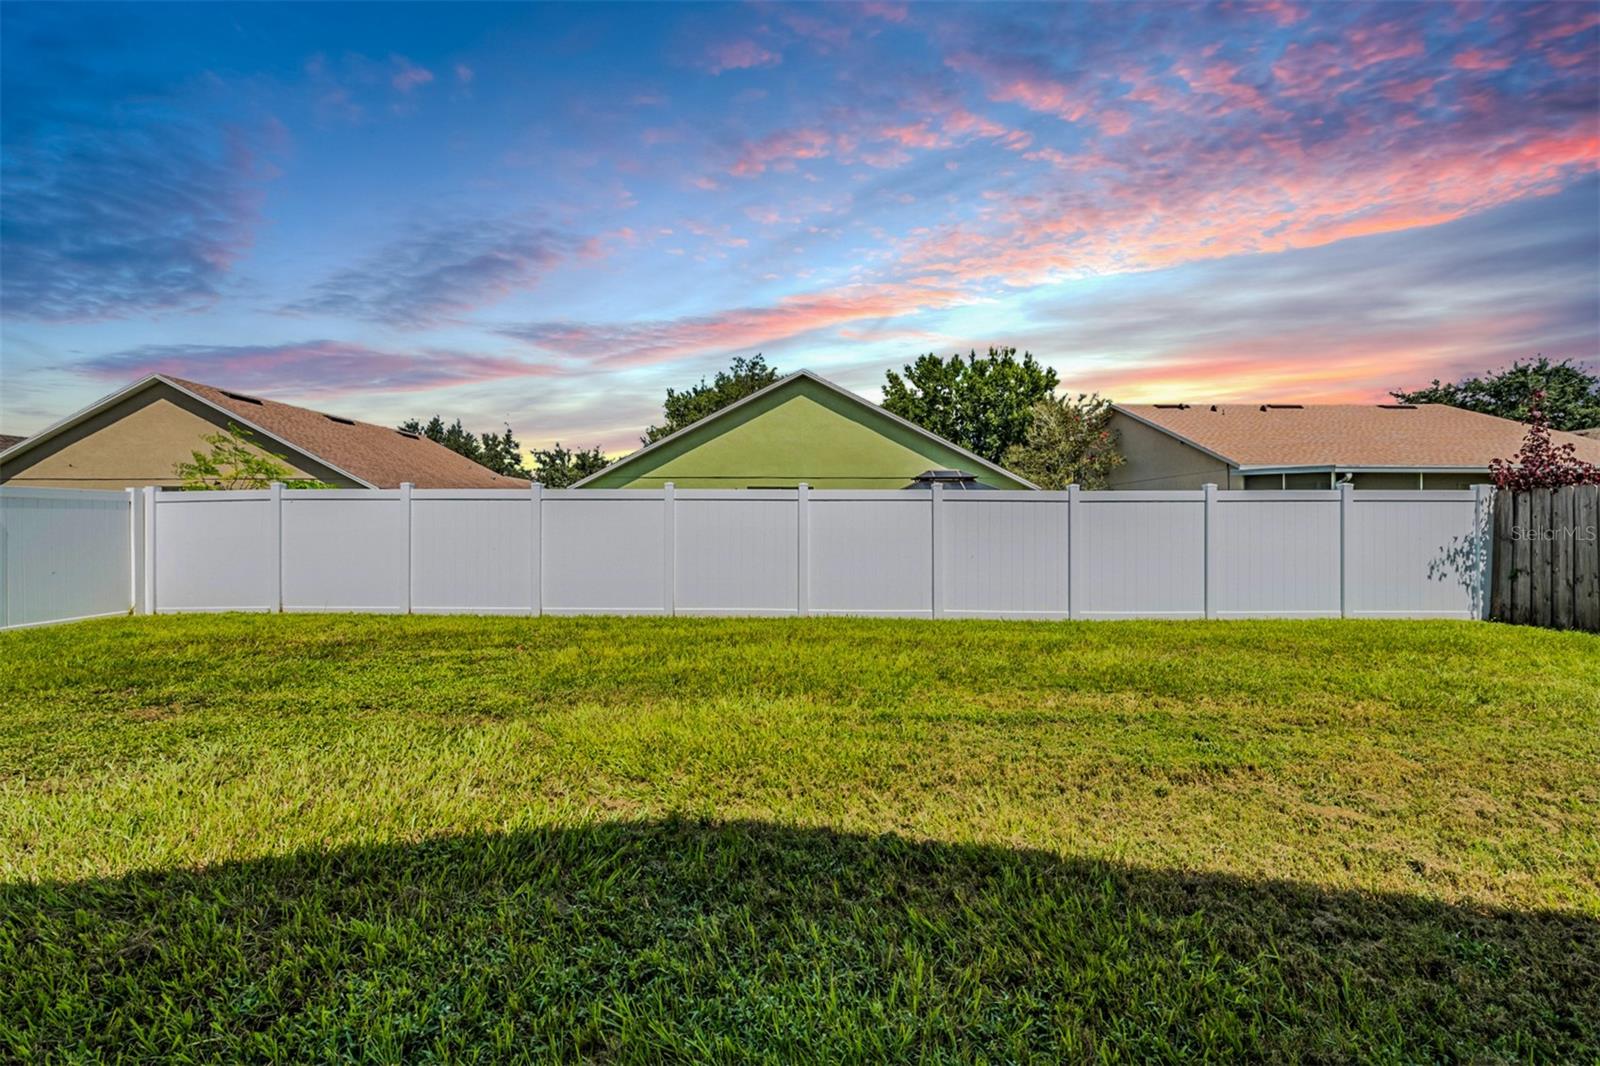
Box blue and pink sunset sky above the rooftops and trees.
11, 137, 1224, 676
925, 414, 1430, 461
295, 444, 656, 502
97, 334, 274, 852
0, 0, 1600, 451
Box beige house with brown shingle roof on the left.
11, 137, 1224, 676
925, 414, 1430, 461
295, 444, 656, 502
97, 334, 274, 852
0, 375, 526, 488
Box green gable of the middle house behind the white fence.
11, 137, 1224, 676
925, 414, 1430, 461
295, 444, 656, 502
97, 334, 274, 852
573, 370, 1034, 488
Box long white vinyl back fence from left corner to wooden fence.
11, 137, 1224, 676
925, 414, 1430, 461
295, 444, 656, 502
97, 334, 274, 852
141, 485, 1490, 618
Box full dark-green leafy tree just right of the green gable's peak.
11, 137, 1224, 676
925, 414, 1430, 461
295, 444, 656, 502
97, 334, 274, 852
883, 347, 1056, 463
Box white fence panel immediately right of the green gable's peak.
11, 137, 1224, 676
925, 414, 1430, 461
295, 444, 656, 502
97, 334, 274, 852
806, 490, 933, 616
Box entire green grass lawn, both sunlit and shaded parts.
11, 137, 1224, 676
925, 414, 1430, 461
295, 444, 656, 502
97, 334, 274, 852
0, 616, 1600, 1063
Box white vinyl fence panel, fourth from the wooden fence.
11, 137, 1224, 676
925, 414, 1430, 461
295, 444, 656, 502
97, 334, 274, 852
938, 491, 1069, 618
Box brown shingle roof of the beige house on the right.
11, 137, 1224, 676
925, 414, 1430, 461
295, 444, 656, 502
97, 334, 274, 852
1117, 403, 1600, 469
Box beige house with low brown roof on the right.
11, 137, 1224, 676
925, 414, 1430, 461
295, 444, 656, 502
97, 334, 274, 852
1109, 403, 1600, 488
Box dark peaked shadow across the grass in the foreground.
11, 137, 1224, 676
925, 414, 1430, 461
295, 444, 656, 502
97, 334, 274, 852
0, 820, 1600, 1061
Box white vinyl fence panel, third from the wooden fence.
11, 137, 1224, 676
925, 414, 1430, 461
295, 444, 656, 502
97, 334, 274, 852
1072, 491, 1205, 618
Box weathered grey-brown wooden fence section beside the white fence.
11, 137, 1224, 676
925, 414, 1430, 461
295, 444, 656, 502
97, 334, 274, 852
1490, 485, 1600, 632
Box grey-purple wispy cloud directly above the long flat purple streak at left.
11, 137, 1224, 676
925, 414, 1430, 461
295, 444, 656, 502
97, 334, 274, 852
283, 221, 598, 327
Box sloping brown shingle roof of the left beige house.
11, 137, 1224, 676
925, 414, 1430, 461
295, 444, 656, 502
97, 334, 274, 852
163, 375, 528, 488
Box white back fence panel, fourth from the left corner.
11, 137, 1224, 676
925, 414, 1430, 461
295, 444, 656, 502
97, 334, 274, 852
541, 488, 669, 615
